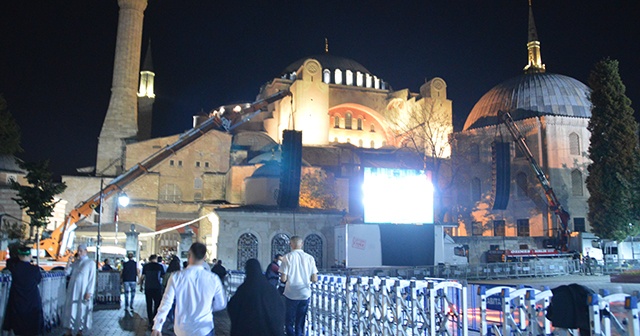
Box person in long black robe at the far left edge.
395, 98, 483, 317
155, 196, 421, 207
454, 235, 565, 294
3, 245, 44, 336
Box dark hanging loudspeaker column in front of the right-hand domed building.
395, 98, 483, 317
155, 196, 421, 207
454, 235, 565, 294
492, 142, 511, 210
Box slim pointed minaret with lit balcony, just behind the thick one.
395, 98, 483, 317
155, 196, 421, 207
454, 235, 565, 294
138, 40, 156, 140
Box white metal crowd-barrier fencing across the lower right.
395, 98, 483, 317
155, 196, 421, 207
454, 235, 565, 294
226, 261, 640, 336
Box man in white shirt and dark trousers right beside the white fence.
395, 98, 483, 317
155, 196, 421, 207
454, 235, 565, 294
280, 236, 318, 336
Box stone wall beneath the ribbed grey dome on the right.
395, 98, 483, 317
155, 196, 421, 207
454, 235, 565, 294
453, 116, 589, 242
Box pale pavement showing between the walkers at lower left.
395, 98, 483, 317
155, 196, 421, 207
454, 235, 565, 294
51, 292, 231, 336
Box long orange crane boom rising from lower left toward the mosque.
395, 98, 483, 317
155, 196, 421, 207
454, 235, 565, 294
34, 90, 291, 261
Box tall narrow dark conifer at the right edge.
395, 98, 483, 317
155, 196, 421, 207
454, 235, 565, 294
587, 59, 640, 241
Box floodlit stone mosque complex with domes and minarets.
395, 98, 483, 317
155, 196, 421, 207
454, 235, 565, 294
61, 0, 590, 268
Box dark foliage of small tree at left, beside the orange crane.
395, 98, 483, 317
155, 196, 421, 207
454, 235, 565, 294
11, 161, 67, 236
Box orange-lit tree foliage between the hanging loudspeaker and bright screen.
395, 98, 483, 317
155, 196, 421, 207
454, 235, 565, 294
300, 169, 338, 209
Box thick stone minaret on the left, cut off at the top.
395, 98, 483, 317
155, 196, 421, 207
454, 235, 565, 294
96, 0, 147, 176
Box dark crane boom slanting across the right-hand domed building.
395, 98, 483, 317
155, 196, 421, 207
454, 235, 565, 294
498, 111, 571, 252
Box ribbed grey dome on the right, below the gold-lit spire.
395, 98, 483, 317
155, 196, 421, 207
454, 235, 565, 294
464, 73, 591, 130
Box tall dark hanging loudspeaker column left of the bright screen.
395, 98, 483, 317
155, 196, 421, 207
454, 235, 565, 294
278, 130, 302, 209
